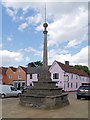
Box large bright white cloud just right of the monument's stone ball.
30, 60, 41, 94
48, 7, 88, 47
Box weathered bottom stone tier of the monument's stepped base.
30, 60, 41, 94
20, 93, 69, 109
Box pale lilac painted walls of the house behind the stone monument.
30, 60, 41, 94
27, 62, 89, 91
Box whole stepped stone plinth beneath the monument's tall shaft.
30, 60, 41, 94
20, 70, 69, 109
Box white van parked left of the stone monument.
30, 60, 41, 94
0, 85, 22, 98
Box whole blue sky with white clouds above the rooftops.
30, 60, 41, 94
0, 0, 89, 66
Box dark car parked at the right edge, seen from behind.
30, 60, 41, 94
76, 85, 90, 99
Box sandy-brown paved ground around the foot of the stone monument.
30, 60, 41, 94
2, 92, 90, 118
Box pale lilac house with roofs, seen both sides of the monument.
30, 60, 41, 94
27, 61, 90, 91
